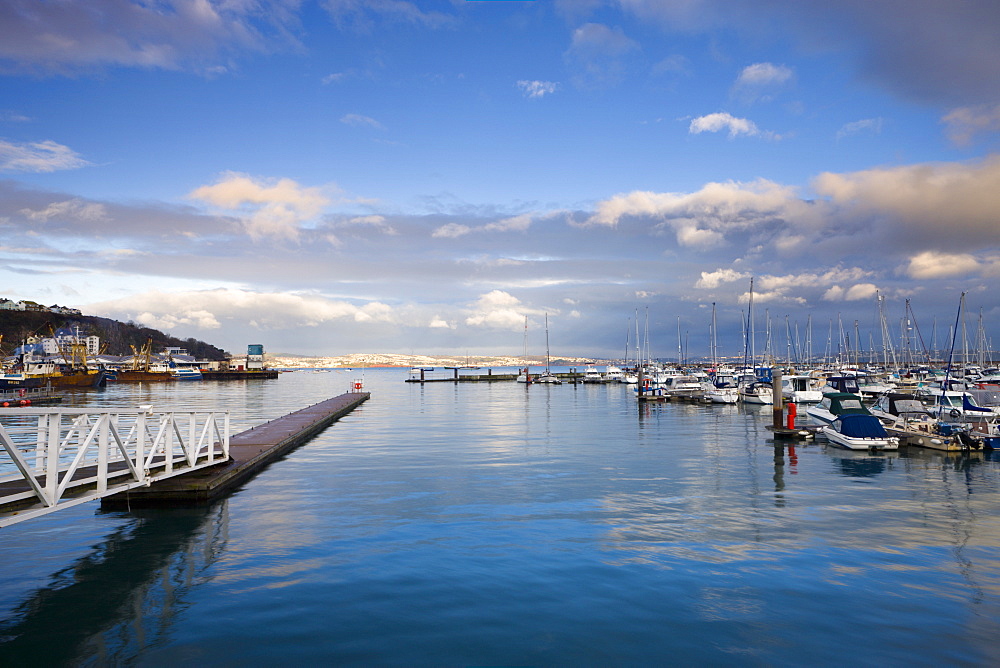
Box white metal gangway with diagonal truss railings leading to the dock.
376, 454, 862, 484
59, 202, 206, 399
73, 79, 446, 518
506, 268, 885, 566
0, 406, 230, 527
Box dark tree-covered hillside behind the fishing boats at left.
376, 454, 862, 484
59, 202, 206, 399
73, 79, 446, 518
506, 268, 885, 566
0, 310, 228, 360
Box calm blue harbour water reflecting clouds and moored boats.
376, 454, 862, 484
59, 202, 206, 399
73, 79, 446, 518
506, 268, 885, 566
0, 369, 1000, 666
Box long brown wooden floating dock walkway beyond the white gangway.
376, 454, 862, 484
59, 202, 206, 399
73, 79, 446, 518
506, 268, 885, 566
101, 392, 371, 509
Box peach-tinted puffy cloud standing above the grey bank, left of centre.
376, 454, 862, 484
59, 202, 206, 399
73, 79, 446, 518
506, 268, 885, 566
190, 172, 330, 240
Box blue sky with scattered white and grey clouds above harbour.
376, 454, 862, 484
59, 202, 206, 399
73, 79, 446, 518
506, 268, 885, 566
0, 0, 1000, 357
